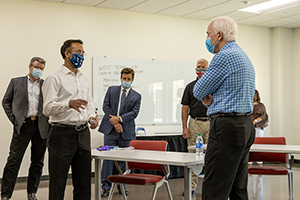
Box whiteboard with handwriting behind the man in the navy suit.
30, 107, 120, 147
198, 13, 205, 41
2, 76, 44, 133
93, 57, 196, 125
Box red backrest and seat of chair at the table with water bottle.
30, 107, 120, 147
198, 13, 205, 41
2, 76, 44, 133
127, 140, 168, 171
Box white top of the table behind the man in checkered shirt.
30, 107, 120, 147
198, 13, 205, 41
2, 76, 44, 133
188, 144, 300, 154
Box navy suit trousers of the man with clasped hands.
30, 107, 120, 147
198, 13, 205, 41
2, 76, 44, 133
101, 128, 131, 190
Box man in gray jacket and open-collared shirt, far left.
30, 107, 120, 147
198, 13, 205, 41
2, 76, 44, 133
1, 57, 49, 200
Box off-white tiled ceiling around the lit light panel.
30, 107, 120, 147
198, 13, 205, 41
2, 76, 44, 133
34, 0, 300, 28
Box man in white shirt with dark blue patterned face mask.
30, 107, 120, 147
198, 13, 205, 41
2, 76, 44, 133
42, 40, 98, 200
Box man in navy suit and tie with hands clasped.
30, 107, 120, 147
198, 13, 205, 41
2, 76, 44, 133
99, 68, 141, 197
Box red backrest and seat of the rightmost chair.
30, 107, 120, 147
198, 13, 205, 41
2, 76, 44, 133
249, 137, 287, 163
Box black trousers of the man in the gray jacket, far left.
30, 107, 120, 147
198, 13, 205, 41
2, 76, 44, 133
1, 120, 46, 198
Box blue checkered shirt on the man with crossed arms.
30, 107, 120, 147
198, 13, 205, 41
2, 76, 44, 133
193, 41, 255, 116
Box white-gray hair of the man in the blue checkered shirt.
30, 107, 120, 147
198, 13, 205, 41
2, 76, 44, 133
212, 16, 238, 42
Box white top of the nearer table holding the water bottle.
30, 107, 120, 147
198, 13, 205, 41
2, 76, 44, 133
92, 149, 204, 166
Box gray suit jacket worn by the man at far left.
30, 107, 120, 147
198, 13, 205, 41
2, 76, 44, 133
2, 76, 49, 139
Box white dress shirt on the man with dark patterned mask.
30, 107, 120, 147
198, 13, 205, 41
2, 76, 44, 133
42, 66, 95, 125
